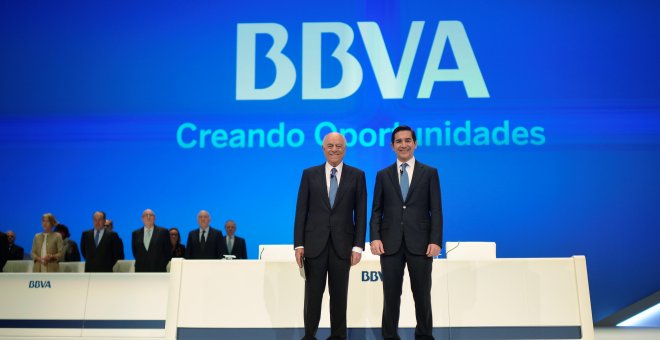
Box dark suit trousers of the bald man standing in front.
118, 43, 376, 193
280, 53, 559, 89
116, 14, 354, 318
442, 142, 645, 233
303, 239, 351, 339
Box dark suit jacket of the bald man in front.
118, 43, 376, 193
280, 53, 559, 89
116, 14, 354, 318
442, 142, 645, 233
293, 163, 367, 259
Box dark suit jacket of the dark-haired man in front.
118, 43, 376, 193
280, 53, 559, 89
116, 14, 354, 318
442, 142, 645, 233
370, 160, 442, 255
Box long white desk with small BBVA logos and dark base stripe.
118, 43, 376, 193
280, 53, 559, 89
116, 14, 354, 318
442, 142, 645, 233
0, 256, 593, 339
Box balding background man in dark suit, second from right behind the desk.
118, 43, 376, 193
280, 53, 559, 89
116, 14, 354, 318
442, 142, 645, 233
186, 210, 227, 260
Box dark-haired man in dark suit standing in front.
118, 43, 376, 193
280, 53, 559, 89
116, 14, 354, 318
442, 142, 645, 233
370, 126, 442, 339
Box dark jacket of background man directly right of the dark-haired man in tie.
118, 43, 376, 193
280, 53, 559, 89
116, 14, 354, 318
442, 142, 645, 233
131, 226, 172, 272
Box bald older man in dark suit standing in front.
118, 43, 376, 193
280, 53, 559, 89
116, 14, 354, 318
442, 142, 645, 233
293, 132, 367, 339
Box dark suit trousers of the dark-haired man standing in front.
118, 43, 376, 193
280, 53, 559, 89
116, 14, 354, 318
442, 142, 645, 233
380, 241, 433, 339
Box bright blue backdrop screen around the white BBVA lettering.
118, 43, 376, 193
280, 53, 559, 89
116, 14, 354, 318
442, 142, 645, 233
0, 0, 660, 321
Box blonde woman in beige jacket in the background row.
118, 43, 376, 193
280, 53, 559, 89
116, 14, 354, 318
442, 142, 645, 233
32, 213, 64, 272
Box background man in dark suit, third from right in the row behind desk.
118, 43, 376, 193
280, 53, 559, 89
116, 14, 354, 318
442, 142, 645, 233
131, 209, 172, 273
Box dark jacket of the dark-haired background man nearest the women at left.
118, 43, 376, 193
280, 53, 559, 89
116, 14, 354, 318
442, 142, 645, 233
80, 228, 119, 273
